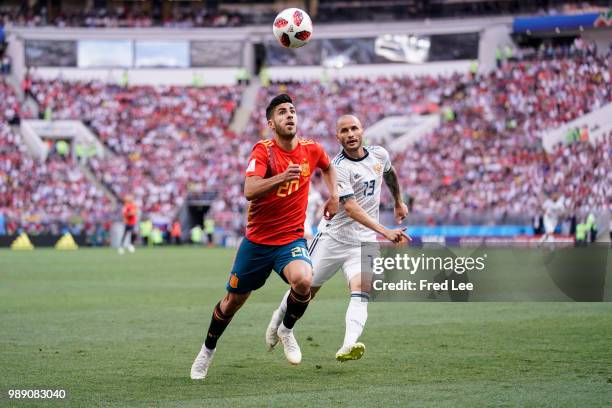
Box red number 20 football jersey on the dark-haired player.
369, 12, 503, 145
246, 139, 330, 245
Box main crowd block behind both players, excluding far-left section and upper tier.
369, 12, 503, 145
1, 49, 612, 236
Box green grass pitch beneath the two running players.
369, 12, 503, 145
0, 248, 612, 408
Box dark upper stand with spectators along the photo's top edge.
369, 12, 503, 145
0, 0, 608, 28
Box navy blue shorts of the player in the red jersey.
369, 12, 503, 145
226, 238, 312, 293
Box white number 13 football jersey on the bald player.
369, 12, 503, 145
319, 146, 391, 245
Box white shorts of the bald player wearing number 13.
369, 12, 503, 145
309, 233, 378, 288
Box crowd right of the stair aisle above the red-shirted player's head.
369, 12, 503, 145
247, 52, 612, 223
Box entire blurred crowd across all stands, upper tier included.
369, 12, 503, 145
0, 2, 612, 245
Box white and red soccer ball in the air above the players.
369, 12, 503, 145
272, 8, 312, 48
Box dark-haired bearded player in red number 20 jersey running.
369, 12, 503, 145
191, 94, 339, 380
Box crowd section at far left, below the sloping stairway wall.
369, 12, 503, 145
0, 83, 112, 234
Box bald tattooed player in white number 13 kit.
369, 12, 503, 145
266, 115, 410, 361
